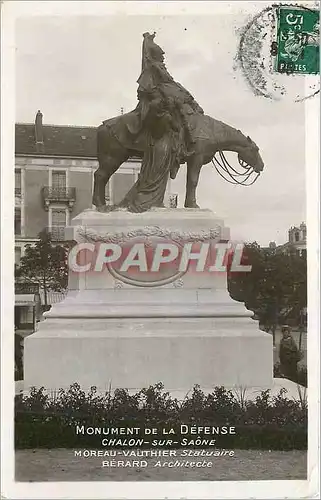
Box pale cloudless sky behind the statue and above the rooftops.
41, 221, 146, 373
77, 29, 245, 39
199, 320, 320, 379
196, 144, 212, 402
16, 2, 306, 245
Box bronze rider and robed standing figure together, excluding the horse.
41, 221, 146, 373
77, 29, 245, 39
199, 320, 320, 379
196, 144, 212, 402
121, 33, 203, 212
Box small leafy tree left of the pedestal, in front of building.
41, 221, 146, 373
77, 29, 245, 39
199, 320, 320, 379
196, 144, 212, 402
15, 231, 68, 306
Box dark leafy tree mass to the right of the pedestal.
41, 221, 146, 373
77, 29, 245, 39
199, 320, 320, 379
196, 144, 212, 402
229, 242, 307, 335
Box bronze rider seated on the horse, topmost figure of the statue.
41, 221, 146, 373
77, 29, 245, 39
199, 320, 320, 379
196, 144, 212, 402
137, 33, 204, 161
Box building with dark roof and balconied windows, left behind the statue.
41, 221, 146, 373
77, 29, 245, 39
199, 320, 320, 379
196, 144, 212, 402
14, 111, 177, 263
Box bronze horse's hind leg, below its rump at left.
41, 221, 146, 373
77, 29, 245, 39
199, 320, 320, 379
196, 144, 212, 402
92, 153, 128, 211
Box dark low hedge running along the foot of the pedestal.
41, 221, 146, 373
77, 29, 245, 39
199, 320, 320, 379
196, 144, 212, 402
15, 383, 307, 450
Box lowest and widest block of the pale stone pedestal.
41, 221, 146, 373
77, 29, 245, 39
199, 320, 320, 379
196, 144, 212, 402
25, 318, 273, 391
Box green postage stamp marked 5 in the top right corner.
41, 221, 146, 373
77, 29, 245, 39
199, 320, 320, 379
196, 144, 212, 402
272, 6, 320, 74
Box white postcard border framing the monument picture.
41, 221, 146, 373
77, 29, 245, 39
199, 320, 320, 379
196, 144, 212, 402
1, 1, 320, 499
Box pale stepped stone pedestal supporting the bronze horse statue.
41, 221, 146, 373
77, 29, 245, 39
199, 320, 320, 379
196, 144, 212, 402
24, 209, 273, 393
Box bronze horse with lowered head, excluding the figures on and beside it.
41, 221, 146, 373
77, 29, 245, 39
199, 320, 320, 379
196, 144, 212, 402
93, 110, 264, 211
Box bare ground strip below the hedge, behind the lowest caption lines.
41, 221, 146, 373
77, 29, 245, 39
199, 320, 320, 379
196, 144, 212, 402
16, 449, 307, 482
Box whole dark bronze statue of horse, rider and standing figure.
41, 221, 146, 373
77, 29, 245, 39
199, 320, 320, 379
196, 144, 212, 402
93, 33, 264, 212
